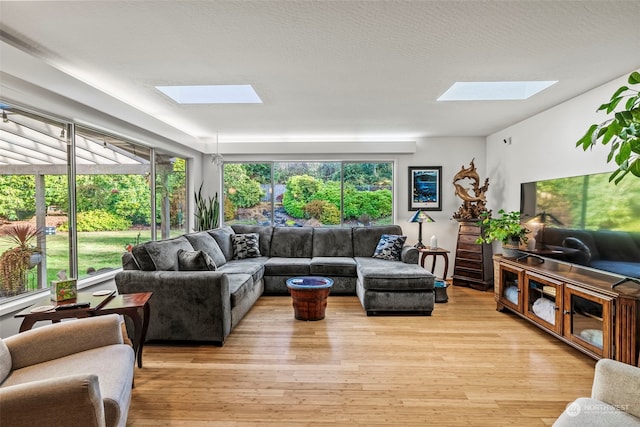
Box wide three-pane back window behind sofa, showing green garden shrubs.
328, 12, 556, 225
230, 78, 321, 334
224, 162, 393, 227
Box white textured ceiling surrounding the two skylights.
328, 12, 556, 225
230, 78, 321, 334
0, 1, 640, 150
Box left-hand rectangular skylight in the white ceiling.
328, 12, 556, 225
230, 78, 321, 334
156, 85, 262, 104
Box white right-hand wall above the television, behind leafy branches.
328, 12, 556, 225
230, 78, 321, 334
487, 73, 630, 211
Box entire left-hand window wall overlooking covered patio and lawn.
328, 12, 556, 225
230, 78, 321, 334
0, 104, 187, 303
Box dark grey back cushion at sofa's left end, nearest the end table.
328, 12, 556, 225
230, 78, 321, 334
132, 236, 193, 271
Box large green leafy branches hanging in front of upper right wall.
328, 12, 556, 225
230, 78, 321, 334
576, 71, 640, 184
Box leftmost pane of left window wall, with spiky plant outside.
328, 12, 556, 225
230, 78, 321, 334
0, 105, 69, 301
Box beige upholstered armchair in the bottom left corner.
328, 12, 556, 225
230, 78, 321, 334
0, 314, 134, 427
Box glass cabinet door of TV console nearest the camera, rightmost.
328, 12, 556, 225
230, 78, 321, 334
563, 285, 613, 357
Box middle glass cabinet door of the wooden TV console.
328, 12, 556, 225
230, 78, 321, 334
524, 273, 562, 334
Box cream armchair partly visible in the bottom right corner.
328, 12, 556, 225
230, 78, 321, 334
553, 359, 640, 427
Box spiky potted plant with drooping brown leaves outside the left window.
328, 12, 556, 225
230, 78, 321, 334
0, 224, 42, 296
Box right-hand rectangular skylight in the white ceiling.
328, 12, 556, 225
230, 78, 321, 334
438, 80, 558, 101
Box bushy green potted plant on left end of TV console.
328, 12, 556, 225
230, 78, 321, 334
476, 209, 529, 257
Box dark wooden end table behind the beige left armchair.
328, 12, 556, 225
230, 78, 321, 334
14, 291, 153, 368
